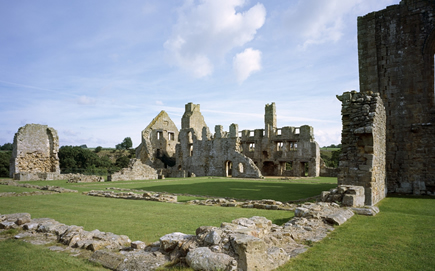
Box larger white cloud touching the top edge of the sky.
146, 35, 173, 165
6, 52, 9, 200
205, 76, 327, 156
164, 0, 266, 77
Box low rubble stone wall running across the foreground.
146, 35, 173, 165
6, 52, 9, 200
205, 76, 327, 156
0, 202, 366, 270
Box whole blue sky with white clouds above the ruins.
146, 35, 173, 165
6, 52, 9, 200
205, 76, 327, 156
0, 0, 399, 147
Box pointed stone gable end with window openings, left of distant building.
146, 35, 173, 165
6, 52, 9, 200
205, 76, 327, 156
136, 110, 178, 168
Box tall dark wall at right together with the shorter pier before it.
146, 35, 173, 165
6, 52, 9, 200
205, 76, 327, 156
338, 0, 435, 204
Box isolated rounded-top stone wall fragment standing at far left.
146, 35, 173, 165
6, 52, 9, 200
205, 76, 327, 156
10, 124, 60, 180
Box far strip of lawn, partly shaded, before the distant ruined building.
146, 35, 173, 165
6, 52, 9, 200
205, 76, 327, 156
21, 177, 337, 202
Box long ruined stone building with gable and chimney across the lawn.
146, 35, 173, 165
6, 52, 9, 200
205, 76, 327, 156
137, 103, 320, 178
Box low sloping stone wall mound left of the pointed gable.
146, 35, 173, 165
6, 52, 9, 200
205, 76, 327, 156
107, 159, 158, 182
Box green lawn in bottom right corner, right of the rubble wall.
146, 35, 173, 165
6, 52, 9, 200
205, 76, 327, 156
278, 197, 435, 271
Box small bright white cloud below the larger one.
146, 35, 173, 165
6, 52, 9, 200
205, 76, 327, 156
233, 48, 261, 83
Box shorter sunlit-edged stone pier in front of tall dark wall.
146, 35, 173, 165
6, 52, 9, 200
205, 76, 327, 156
337, 91, 387, 205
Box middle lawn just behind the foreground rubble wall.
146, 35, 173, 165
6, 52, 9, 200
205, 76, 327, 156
0, 193, 293, 244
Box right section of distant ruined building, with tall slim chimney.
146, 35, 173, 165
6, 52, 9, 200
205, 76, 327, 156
241, 103, 320, 177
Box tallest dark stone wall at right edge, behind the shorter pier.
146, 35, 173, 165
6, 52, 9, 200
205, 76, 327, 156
358, 0, 435, 194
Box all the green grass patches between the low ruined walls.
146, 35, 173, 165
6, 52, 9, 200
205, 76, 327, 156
0, 178, 435, 271
